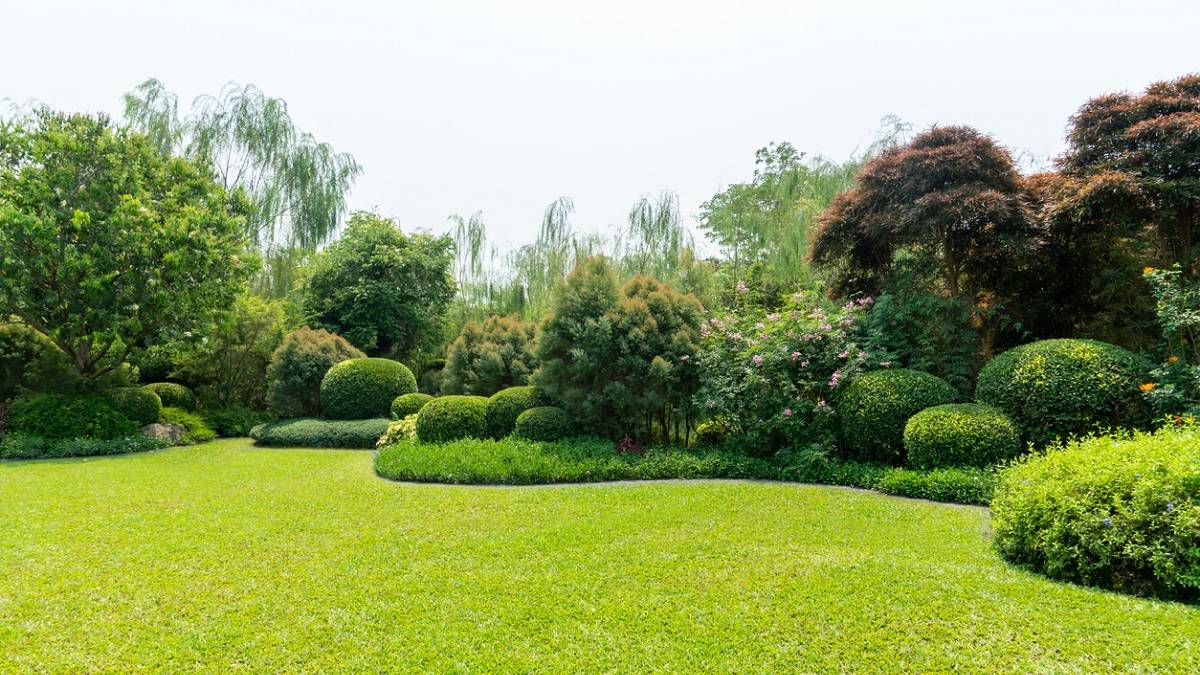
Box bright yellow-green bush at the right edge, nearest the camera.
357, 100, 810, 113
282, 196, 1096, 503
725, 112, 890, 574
991, 426, 1200, 599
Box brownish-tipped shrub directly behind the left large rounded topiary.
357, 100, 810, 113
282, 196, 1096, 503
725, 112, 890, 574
266, 327, 366, 418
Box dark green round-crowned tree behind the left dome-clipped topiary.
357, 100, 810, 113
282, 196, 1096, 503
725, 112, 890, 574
304, 211, 455, 360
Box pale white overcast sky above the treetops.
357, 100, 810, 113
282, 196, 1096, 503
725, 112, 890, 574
0, 0, 1200, 244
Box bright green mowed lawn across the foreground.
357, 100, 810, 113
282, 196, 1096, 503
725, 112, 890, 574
0, 441, 1200, 673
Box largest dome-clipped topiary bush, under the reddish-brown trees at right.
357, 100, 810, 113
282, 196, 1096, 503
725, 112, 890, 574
976, 340, 1147, 447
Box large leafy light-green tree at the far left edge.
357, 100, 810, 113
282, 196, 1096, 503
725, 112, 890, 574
0, 109, 254, 381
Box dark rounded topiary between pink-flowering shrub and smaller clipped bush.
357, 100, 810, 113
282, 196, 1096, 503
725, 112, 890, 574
836, 369, 959, 464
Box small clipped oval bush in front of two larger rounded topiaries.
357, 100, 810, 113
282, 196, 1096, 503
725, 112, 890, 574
904, 404, 1021, 468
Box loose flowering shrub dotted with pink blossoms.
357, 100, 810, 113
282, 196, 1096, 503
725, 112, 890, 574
694, 292, 892, 453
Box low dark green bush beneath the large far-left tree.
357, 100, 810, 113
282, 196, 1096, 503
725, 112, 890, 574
10, 394, 138, 440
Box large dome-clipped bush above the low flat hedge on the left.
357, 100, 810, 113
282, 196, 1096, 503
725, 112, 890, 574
320, 359, 416, 419
